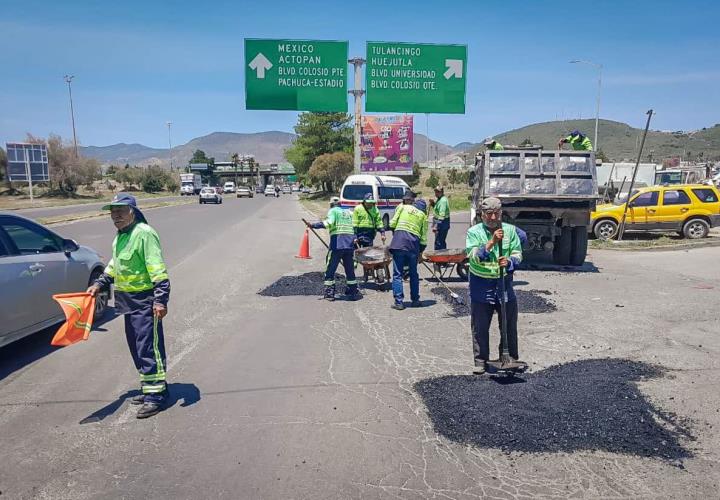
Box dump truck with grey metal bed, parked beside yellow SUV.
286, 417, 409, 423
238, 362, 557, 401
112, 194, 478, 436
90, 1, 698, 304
470, 148, 598, 266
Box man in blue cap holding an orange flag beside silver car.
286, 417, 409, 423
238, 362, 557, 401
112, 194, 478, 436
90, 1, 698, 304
87, 193, 170, 418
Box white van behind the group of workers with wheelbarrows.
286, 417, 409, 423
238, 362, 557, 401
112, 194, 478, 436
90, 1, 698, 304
340, 175, 410, 227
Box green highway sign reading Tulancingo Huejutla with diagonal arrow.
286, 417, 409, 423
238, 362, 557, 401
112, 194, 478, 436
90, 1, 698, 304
365, 42, 467, 113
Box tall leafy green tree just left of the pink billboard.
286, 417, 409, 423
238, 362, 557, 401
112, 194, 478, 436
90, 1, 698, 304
285, 113, 353, 176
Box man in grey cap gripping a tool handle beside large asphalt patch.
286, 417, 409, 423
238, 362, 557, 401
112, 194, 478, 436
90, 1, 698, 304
465, 198, 522, 374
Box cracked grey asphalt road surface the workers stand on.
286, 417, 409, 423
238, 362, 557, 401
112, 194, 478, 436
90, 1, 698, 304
0, 196, 720, 499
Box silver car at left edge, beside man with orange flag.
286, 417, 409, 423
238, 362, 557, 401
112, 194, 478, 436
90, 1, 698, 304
0, 212, 109, 346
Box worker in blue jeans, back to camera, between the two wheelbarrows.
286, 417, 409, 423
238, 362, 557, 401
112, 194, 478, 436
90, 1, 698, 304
390, 196, 428, 311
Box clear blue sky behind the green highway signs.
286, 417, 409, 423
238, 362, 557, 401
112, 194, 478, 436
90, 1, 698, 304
0, 0, 720, 147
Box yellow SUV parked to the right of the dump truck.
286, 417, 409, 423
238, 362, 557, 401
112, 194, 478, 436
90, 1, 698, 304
590, 184, 720, 240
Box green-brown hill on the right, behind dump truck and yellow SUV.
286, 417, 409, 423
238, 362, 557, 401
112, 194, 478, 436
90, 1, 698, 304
472, 120, 720, 161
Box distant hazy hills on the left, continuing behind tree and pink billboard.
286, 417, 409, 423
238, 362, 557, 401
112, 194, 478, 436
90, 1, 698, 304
81, 131, 453, 167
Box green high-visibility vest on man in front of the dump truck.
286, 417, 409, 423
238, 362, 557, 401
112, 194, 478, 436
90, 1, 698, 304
465, 222, 522, 279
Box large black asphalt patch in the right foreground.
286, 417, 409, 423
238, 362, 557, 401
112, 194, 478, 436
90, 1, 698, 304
415, 359, 692, 465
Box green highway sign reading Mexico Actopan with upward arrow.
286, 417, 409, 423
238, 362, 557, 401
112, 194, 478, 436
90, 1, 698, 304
245, 38, 348, 112
